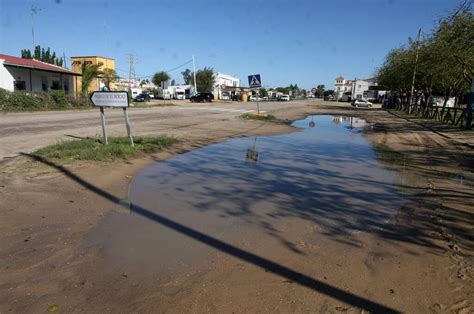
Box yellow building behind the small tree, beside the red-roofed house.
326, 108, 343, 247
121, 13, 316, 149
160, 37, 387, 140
71, 56, 115, 95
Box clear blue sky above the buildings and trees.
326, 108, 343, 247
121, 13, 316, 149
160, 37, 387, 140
0, 0, 461, 88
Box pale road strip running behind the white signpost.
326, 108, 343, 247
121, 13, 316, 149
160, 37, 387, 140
0, 102, 295, 161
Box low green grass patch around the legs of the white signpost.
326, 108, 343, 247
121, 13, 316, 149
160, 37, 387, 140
35, 135, 178, 161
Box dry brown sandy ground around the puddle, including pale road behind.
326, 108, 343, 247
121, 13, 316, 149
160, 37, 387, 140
0, 101, 474, 313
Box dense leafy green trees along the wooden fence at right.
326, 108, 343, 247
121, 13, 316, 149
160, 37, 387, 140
377, 2, 474, 127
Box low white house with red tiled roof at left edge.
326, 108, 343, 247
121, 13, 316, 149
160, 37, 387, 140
0, 54, 81, 96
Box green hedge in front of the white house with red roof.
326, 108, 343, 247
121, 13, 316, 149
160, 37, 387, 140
0, 88, 92, 112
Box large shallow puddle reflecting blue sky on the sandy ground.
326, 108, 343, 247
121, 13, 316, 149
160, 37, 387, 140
84, 116, 404, 272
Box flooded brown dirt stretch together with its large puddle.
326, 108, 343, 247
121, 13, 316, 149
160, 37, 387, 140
0, 103, 474, 313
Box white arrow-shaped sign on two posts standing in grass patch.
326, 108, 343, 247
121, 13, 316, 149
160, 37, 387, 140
90, 92, 135, 146
